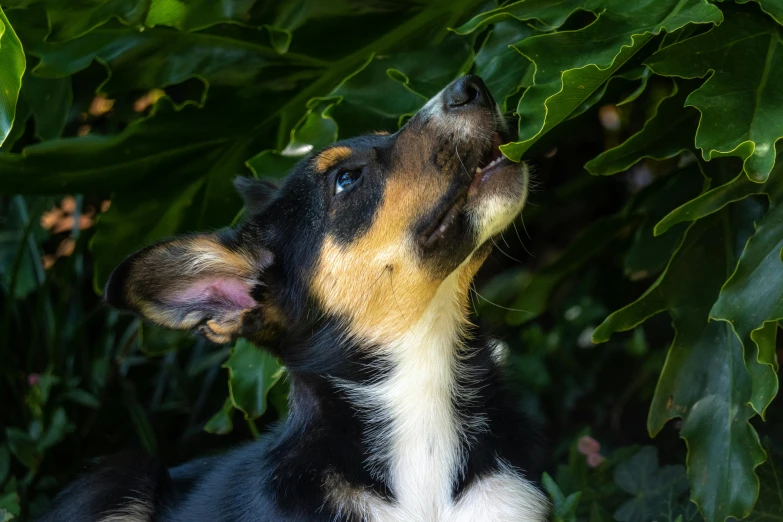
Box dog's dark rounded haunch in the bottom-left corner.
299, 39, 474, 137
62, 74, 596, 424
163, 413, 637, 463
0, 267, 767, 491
39, 451, 171, 522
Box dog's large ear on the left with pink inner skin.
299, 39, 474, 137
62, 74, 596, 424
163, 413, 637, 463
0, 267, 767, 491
104, 231, 274, 343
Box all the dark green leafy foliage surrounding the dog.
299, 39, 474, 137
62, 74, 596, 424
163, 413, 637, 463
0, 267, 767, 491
0, 0, 783, 522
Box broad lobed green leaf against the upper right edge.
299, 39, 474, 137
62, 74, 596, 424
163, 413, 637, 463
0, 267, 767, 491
646, 6, 783, 182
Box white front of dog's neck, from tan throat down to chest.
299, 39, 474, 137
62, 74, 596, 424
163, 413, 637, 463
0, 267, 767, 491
346, 264, 470, 504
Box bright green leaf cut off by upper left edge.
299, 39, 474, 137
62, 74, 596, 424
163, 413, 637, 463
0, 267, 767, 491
0, 7, 26, 145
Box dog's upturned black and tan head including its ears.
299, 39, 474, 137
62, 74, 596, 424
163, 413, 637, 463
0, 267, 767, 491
105, 76, 527, 354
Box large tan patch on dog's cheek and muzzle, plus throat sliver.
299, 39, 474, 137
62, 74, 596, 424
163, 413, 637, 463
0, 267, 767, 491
313, 154, 486, 343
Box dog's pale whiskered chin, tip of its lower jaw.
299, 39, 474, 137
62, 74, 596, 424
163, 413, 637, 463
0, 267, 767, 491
465, 158, 529, 246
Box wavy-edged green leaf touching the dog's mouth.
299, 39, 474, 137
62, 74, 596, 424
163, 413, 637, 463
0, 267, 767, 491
501, 0, 723, 161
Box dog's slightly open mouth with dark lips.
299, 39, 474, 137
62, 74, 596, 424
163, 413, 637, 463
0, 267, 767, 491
422, 131, 516, 247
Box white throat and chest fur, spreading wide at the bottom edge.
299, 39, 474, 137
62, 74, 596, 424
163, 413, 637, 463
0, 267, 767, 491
330, 270, 548, 522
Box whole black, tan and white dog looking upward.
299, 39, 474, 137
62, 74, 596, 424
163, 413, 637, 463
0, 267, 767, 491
43, 75, 549, 522
